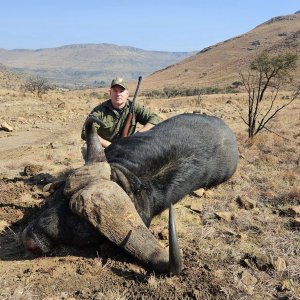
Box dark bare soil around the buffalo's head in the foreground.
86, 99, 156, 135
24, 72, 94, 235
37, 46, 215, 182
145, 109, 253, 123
0, 176, 223, 299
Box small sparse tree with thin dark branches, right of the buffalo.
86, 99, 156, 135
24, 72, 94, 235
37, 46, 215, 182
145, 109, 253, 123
240, 53, 300, 138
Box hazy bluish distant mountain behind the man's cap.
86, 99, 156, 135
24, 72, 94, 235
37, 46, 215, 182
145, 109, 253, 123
0, 44, 195, 86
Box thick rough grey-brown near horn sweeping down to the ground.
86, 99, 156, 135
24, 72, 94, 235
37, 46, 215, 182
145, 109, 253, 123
70, 180, 181, 274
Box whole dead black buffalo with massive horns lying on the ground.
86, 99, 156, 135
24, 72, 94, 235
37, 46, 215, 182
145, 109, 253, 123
22, 114, 238, 274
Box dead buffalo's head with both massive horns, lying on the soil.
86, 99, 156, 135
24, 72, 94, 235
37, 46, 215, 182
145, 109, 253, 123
22, 117, 182, 274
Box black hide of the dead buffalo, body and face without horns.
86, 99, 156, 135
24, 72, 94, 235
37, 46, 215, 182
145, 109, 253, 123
23, 114, 238, 253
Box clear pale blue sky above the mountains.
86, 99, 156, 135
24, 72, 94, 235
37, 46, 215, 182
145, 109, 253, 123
0, 0, 300, 51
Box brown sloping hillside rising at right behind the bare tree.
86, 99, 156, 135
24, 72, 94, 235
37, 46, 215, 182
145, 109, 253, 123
141, 12, 300, 91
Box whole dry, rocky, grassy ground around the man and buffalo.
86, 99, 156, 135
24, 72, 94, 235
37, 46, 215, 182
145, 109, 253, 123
0, 89, 300, 300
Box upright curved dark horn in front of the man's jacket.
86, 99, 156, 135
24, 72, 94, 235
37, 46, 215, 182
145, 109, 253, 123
84, 116, 106, 164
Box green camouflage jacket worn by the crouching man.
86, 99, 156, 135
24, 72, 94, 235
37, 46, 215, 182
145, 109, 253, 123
81, 99, 161, 142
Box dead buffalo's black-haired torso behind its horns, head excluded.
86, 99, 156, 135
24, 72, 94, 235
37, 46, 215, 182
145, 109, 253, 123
105, 114, 238, 225
